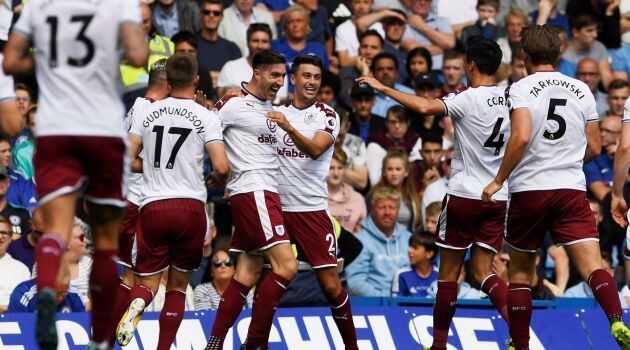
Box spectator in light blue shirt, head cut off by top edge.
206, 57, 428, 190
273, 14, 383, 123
152, 0, 201, 38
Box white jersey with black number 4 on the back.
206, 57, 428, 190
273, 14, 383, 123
441, 86, 510, 200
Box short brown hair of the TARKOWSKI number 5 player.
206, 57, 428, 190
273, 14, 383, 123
521, 24, 562, 65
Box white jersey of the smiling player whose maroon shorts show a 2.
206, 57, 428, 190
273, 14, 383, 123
275, 102, 339, 212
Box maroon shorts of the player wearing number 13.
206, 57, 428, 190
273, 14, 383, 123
33, 136, 129, 208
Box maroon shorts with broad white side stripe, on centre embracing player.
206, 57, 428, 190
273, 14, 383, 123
230, 191, 291, 253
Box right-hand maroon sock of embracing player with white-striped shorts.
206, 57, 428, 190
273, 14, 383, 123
247, 271, 290, 346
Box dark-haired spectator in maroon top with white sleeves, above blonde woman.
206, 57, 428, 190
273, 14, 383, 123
367, 106, 421, 183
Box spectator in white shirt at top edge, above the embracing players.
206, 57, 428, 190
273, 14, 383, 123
219, 0, 277, 56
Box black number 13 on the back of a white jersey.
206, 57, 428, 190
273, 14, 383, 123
46, 15, 95, 68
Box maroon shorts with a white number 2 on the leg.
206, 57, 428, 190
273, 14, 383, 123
284, 210, 337, 269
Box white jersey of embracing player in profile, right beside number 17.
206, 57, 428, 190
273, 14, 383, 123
215, 89, 278, 196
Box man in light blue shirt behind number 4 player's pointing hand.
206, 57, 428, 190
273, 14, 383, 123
372, 52, 413, 118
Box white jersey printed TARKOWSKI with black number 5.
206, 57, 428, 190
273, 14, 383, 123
508, 72, 599, 193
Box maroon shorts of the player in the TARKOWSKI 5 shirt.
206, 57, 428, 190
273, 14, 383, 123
505, 189, 599, 252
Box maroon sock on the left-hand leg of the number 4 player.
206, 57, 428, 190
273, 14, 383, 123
431, 281, 459, 350
